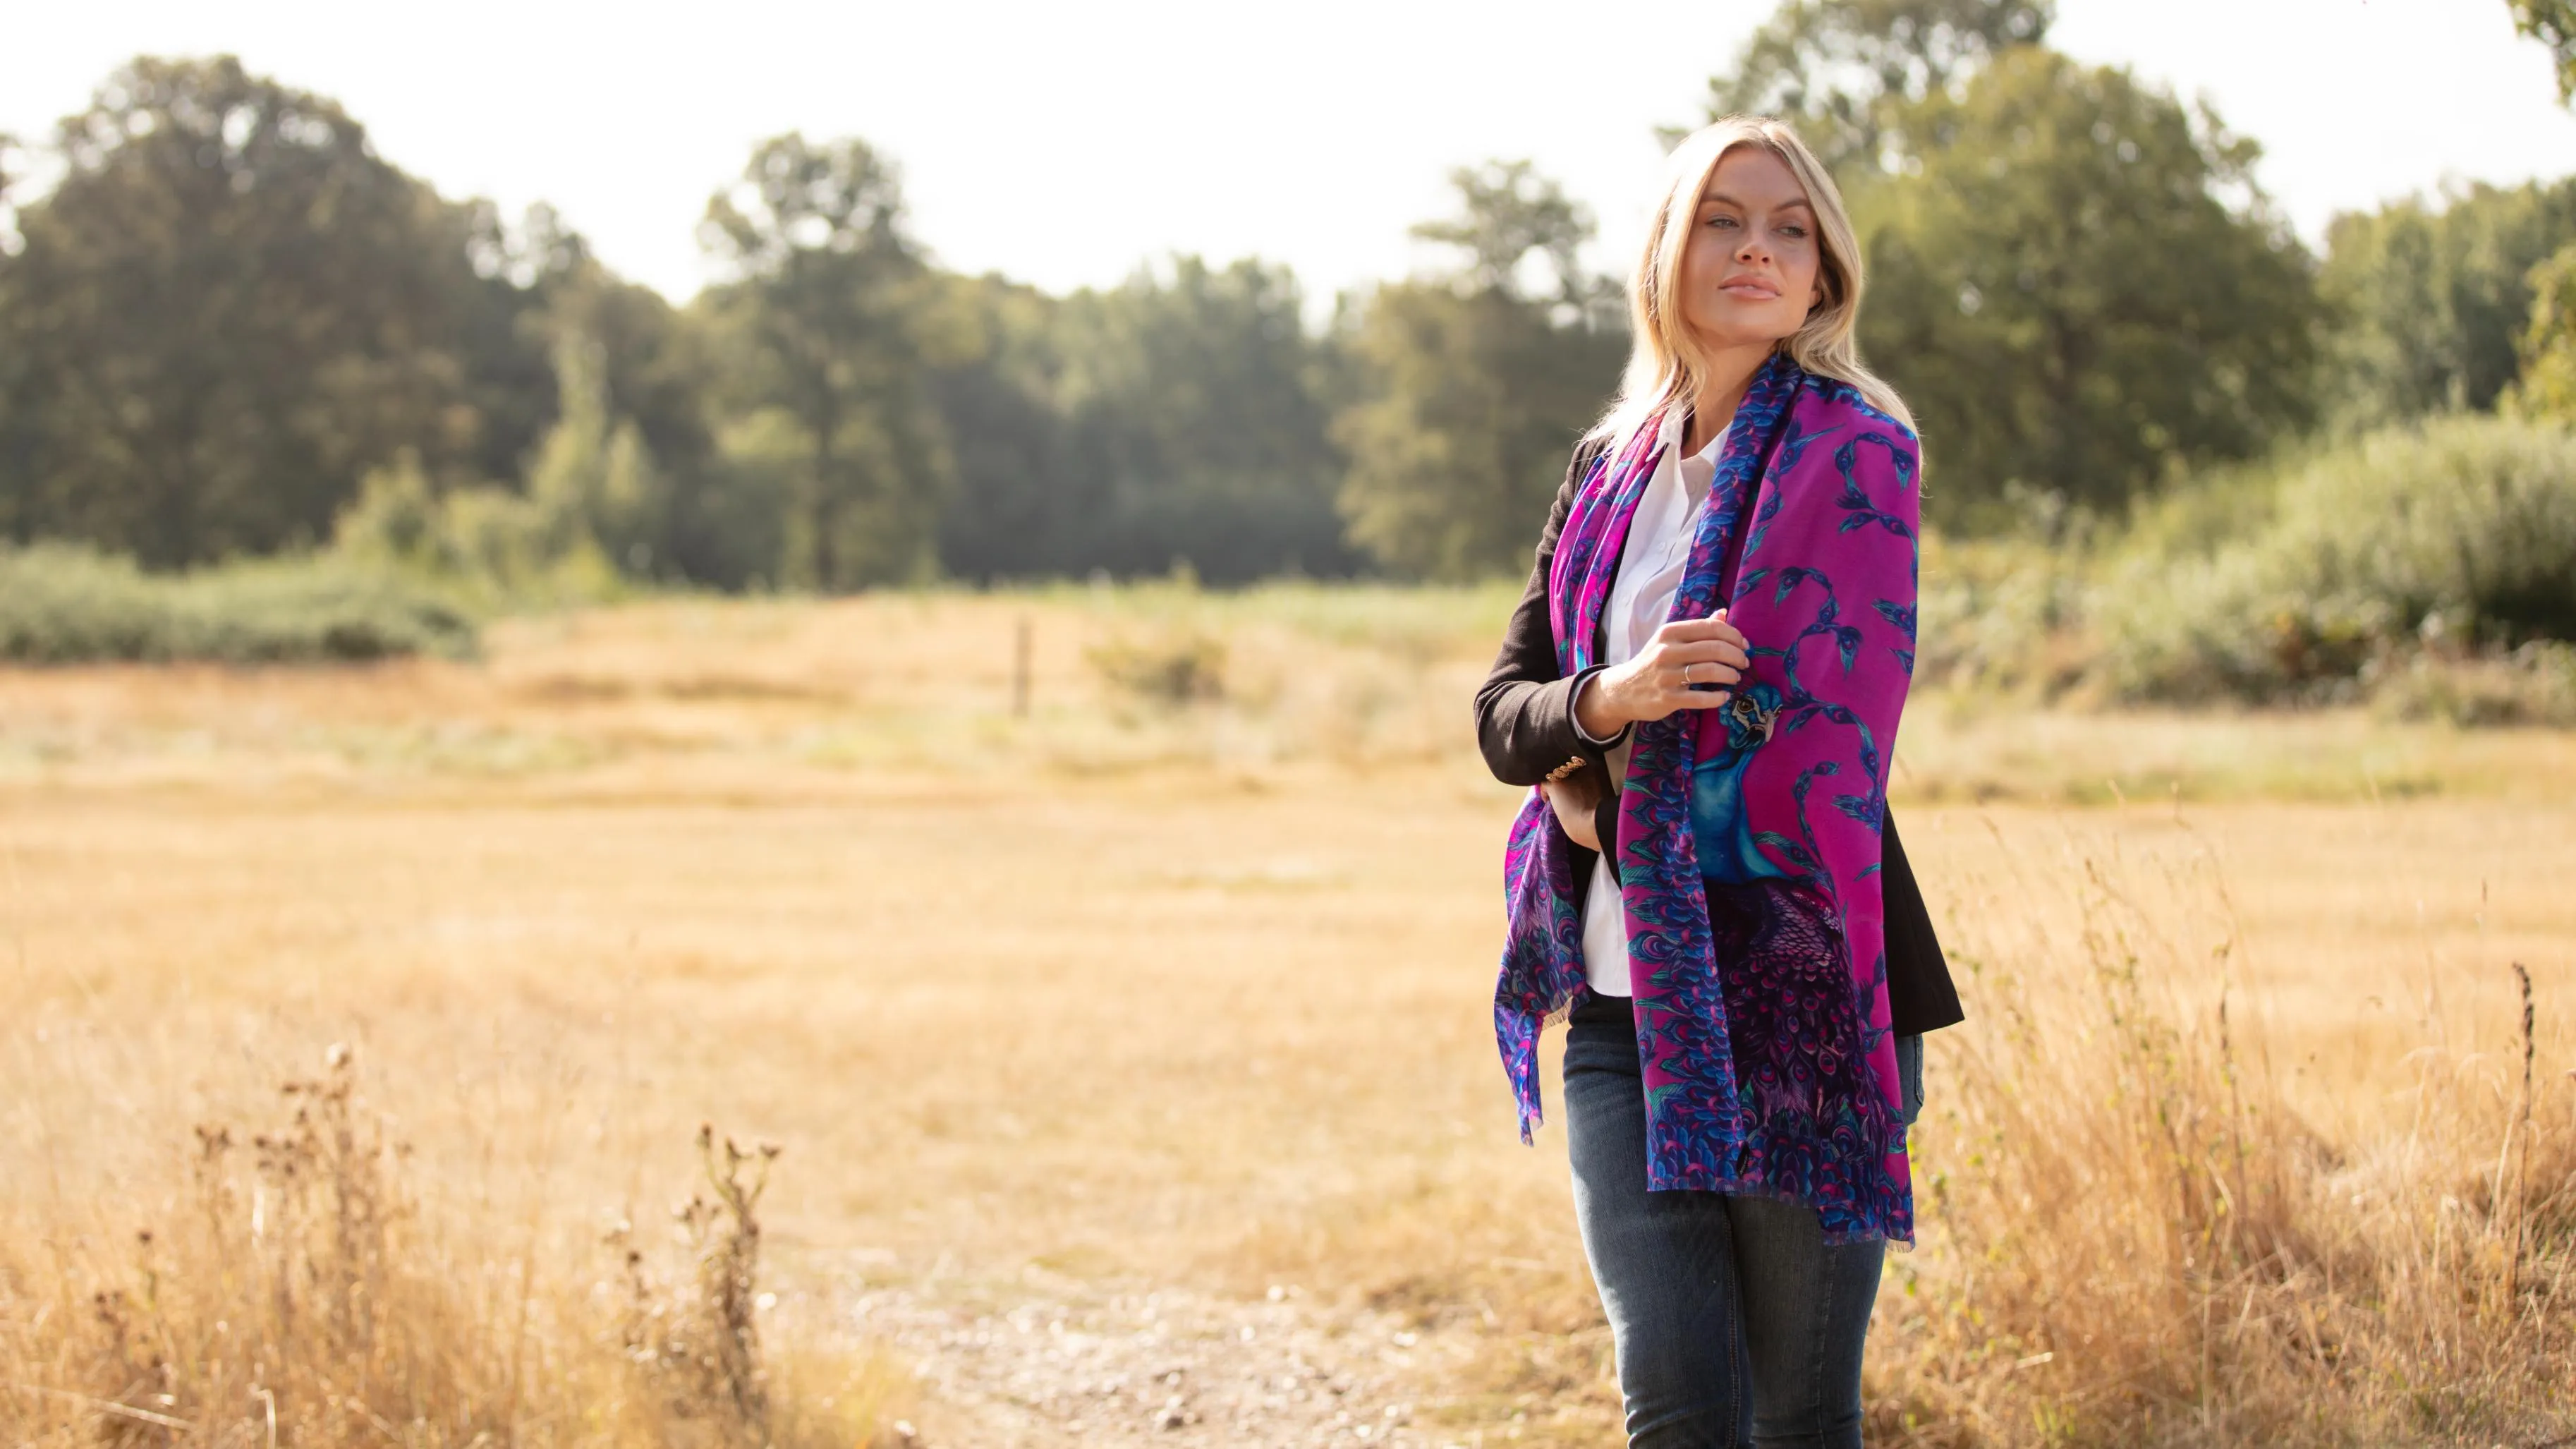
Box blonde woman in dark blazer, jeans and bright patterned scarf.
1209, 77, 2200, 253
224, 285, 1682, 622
1476, 116, 1960, 1449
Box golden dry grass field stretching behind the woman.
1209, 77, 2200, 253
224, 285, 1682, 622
0, 588, 2576, 1449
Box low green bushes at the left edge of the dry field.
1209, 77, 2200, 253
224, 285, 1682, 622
0, 544, 474, 665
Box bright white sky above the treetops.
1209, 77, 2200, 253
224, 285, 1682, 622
15, 0, 2576, 299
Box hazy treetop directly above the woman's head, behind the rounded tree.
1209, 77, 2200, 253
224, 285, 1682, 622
1708, 0, 2055, 173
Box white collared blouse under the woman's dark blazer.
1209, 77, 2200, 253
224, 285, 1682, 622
1576, 413, 1726, 995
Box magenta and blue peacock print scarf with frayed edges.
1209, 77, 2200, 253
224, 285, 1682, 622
1494, 356, 1919, 1243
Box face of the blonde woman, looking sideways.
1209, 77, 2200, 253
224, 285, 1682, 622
1682, 147, 1824, 348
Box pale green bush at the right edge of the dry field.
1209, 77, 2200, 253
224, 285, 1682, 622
2094, 418, 2576, 701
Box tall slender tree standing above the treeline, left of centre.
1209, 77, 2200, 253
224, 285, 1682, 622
700, 134, 951, 588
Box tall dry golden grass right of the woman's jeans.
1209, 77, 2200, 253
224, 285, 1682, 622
1873, 825, 2576, 1446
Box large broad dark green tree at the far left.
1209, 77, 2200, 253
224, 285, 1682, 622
0, 56, 552, 564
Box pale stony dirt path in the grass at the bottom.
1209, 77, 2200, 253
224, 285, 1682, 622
853, 1284, 1471, 1449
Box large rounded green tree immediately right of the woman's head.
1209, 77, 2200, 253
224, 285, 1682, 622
1860, 47, 2321, 523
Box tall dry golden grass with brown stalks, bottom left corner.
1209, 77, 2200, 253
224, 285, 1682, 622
0, 1047, 897, 1449
